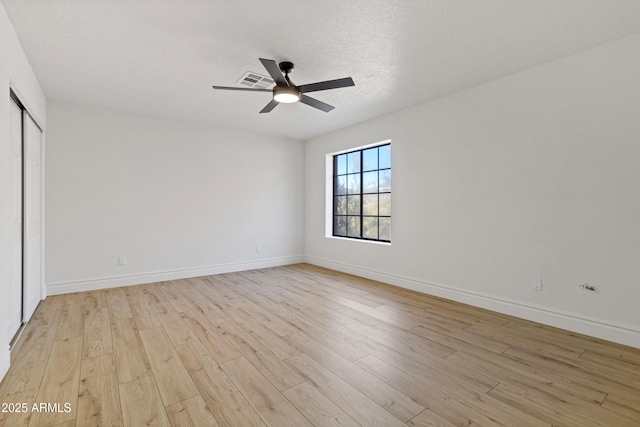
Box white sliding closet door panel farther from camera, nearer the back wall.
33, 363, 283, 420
23, 111, 42, 322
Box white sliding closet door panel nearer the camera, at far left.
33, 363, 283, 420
8, 100, 22, 337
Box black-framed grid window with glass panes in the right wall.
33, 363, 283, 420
333, 144, 391, 242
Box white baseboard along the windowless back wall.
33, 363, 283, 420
46, 256, 304, 295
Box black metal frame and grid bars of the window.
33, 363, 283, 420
331, 142, 392, 243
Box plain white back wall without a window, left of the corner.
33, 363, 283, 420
46, 101, 304, 295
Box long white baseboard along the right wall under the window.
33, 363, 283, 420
305, 256, 640, 348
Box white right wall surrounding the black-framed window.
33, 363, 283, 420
305, 35, 640, 347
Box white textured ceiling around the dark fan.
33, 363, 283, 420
1, 0, 640, 139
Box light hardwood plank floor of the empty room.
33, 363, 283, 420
0, 264, 640, 427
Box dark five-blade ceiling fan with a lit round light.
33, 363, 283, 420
213, 58, 355, 113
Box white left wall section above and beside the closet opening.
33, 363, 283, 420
0, 4, 46, 378
